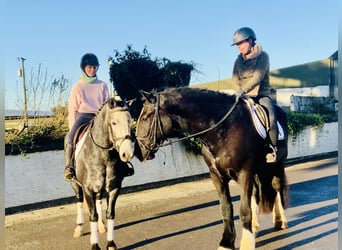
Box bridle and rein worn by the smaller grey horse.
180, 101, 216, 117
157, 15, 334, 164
89, 107, 133, 152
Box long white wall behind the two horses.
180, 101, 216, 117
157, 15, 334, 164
5, 122, 338, 208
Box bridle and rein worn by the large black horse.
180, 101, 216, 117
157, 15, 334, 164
136, 93, 239, 152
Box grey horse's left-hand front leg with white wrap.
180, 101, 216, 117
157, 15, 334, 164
84, 189, 100, 250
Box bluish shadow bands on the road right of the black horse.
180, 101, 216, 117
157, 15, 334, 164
256, 174, 338, 250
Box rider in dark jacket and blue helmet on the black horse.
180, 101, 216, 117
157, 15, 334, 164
232, 27, 278, 163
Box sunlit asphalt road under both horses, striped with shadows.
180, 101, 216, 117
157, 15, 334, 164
5, 157, 338, 250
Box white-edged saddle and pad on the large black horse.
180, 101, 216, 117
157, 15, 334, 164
241, 96, 285, 140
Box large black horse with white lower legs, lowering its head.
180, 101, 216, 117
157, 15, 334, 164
135, 88, 287, 249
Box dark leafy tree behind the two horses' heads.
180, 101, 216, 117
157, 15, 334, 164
109, 45, 195, 118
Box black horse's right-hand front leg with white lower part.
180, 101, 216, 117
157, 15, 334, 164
238, 171, 256, 250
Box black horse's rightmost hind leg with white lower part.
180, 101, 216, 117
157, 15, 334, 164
272, 177, 287, 230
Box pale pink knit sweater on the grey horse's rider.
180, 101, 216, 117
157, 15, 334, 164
68, 80, 109, 129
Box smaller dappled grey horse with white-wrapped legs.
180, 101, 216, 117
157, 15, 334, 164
67, 98, 134, 250
